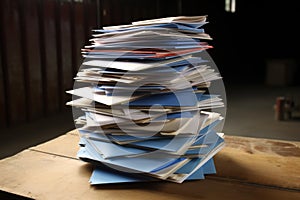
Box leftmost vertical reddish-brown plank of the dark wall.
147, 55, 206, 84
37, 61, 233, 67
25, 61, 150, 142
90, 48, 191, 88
1, 0, 26, 125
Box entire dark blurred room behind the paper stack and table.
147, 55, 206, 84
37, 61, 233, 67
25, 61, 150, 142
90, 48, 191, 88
0, 0, 300, 158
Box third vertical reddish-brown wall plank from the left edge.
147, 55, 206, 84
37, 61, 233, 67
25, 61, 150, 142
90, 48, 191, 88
40, 0, 61, 115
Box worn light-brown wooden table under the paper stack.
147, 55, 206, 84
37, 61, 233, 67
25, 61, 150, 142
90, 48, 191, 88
0, 131, 300, 200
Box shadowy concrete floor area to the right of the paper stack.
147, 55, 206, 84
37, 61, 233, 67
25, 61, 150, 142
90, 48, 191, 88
223, 85, 300, 141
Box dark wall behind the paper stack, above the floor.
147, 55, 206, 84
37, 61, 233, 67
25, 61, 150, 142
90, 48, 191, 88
0, 0, 300, 127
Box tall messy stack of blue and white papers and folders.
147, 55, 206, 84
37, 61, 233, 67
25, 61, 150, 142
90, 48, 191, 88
67, 16, 224, 185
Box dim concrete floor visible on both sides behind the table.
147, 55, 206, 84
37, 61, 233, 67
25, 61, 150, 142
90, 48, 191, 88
0, 85, 300, 159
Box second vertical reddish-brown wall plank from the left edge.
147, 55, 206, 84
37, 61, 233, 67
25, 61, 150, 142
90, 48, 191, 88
21, 0, 44, 120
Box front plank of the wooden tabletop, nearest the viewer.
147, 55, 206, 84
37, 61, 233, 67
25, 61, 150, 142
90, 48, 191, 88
0, 150, 300, 200
